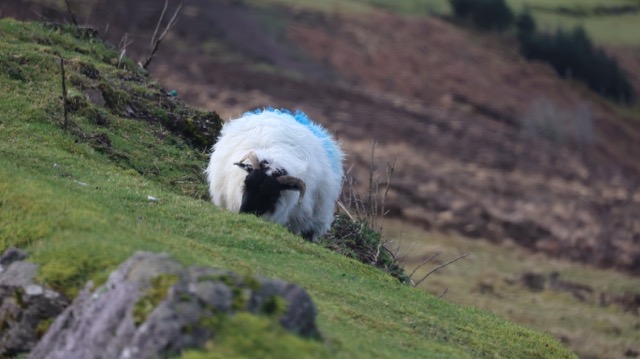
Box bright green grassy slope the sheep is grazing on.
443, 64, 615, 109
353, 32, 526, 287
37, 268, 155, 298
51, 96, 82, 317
0, 20, 574, 358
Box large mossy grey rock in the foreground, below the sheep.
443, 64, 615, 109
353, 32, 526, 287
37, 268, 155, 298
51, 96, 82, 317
30, 252, 319, 359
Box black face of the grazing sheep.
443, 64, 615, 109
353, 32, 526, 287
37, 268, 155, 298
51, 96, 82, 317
240, 170, 287, 216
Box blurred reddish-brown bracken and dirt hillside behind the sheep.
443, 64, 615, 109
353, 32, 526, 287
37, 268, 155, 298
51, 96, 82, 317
5, 0, 640, 274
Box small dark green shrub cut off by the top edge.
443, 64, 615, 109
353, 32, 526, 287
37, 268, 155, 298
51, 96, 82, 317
449, 0, 514, 31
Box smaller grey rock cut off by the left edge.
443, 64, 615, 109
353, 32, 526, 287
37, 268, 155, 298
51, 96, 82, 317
0, 248, 68, 358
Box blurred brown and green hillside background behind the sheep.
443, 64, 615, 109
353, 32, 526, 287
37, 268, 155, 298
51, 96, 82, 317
0, 0, 640, 358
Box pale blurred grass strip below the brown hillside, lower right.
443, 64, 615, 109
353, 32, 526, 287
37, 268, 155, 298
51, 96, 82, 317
385, 221, 640, 359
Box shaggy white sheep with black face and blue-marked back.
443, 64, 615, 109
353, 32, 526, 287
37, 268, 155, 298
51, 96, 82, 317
205, 108, 344, 242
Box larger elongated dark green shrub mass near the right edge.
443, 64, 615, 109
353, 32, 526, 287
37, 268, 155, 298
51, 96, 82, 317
518, 24, 635, 103
